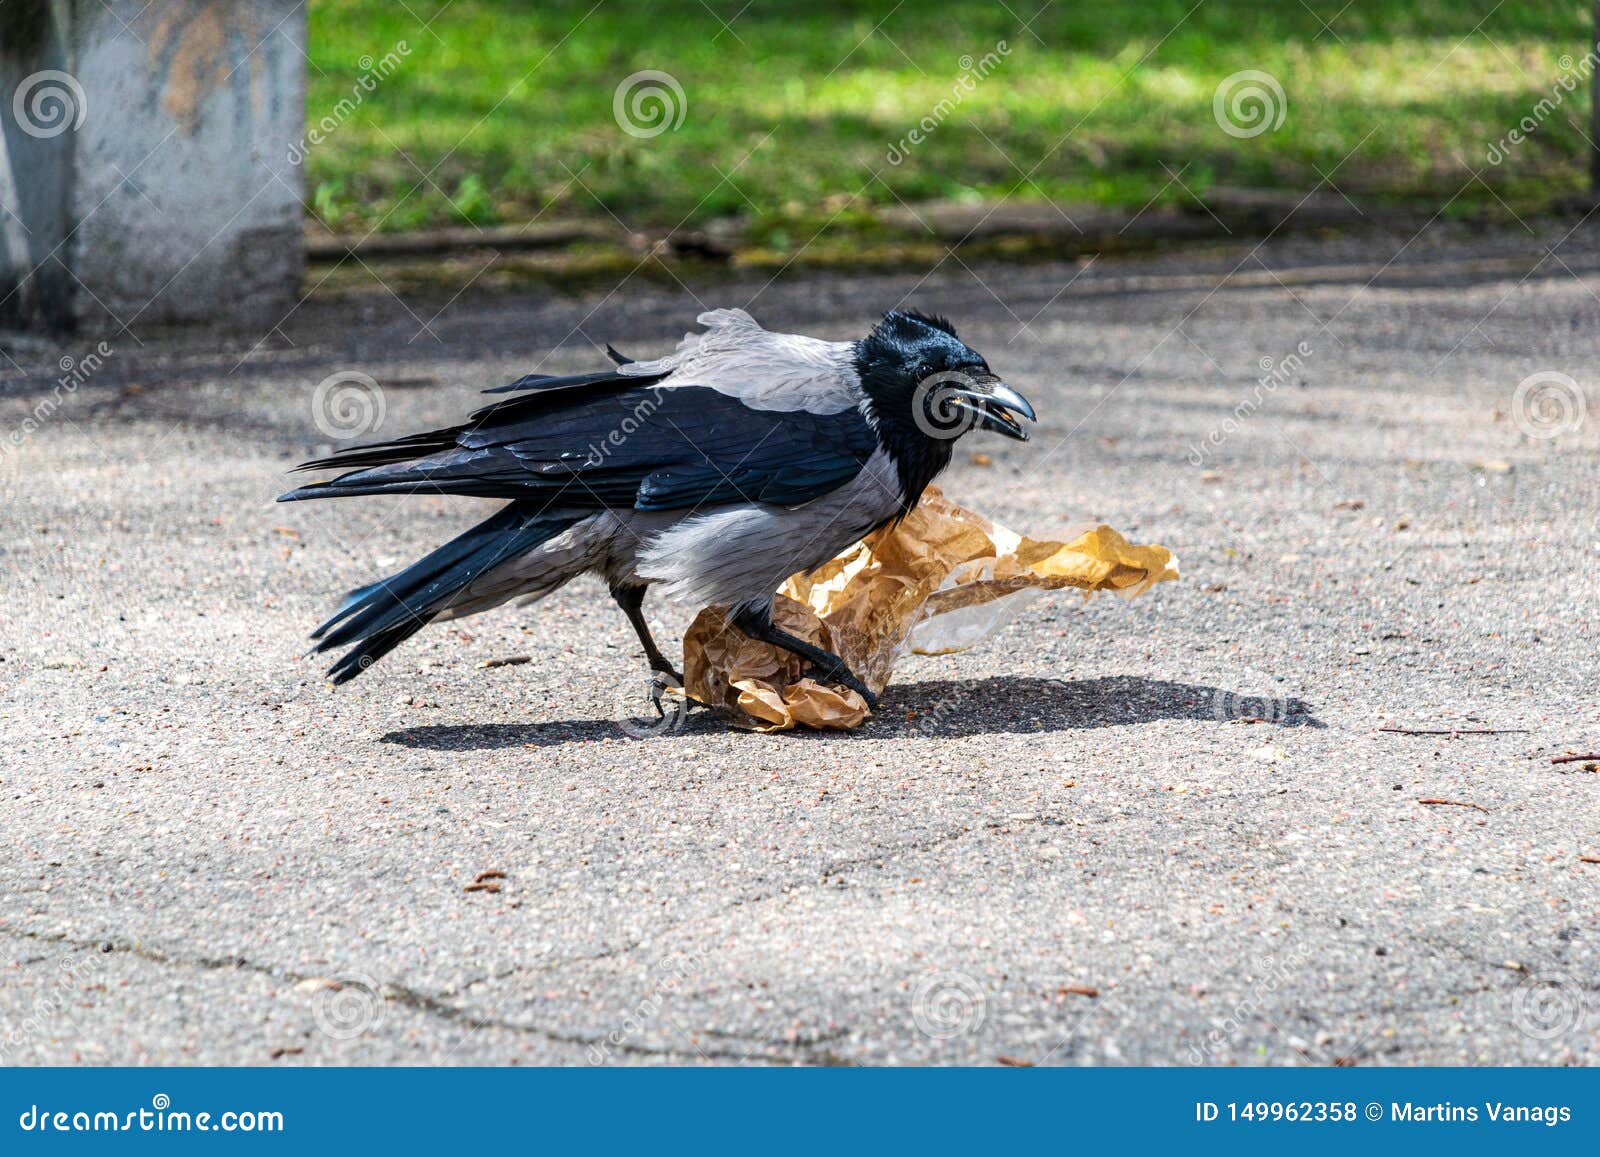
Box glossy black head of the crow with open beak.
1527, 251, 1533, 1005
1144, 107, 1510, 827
856, 309, 1034, 502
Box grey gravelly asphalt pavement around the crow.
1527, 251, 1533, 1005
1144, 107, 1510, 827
0, 222, 1600, 1064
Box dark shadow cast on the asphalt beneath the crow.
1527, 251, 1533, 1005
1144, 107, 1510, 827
381, 675, 1323, 751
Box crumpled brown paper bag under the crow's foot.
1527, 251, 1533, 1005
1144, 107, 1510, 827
683, 486, 1178, 731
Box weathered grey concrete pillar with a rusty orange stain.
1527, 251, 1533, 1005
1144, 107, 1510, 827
0, 0, 306, 333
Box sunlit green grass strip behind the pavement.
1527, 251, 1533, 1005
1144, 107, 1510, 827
307, 0, 1589, 236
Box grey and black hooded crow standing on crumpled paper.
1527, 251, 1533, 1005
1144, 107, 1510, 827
278, 309, 1034, 709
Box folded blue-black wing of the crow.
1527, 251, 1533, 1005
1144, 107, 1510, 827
283, 374, 877, 510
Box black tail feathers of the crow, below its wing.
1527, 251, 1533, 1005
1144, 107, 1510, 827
312, 502, 581, 683
